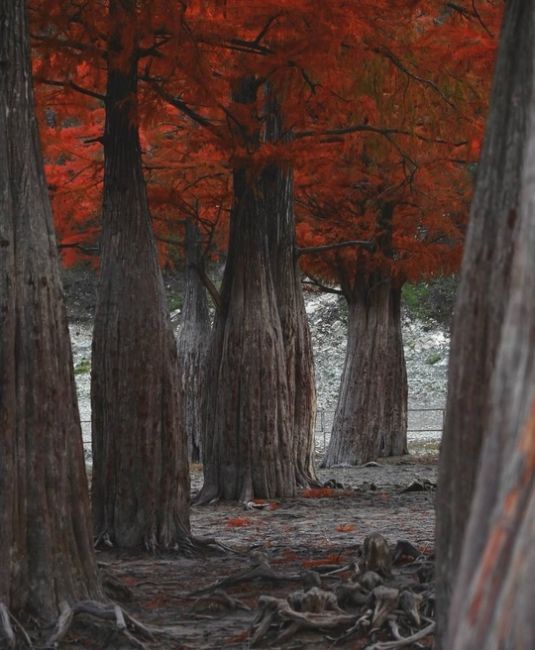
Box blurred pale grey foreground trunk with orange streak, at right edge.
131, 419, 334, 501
446, 58, 535, 650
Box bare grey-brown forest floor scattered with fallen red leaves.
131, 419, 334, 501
66, 456, 437, 650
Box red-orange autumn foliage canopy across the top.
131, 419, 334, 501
32, 0, 500, 282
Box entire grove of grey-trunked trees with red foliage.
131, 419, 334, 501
0, 0, 535, 650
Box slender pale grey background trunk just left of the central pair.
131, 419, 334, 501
178, 220, 210, 463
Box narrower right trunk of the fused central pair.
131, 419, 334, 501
262, 91, 318, 487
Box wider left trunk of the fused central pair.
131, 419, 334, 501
200, 157, 296, 501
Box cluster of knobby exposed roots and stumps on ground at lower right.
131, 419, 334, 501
245, 534, 434, 650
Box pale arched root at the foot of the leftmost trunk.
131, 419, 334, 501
45, 600, 156, 650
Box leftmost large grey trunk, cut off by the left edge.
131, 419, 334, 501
0, 0, 100, 620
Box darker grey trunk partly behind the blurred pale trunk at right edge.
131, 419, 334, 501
437, 1, 534, 636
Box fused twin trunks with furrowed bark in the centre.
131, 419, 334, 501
199, 78, 315, 501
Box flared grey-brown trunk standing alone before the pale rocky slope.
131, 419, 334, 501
323, 277, 407, 467
